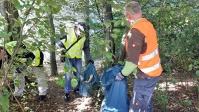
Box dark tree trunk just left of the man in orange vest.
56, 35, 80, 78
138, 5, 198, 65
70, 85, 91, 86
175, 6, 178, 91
103, 0, 115, 66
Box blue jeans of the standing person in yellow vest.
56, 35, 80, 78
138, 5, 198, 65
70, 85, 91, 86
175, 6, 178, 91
64, 58, 82, 94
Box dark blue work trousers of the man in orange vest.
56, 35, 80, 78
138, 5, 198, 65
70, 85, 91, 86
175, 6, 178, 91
129, 76, 160, 112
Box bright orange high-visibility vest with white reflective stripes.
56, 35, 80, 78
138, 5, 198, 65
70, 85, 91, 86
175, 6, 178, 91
126, 18, 162, 77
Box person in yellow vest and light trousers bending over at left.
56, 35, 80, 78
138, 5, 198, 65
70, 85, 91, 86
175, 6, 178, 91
0, 41, 48, 101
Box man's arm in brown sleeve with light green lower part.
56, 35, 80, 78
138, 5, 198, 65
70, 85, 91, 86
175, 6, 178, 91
121, 29, 145, 76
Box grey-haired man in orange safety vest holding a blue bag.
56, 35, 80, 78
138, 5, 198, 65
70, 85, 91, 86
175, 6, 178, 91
115, 1, 162, 112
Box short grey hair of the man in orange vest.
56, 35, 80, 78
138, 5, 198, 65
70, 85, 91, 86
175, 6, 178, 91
125, 1, 142, 15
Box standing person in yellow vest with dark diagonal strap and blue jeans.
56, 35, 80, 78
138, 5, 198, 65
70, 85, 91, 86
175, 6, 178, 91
56, 23, 94, 101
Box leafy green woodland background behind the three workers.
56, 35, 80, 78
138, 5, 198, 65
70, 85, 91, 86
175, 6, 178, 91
0, 0, 199, 110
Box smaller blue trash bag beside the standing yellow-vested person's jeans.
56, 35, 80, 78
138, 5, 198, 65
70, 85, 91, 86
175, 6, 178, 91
79, 63, 100, 96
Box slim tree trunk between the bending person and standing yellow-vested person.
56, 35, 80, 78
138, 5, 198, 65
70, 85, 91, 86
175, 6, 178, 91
49, 6, 58, 76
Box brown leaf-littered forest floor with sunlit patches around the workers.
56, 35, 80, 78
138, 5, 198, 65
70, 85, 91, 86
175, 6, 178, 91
10, 62, 199, 112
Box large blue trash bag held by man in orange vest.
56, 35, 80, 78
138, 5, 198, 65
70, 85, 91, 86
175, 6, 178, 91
100, 66, 129, 112
